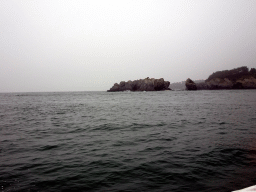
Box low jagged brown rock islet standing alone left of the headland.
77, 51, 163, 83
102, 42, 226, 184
108, 77, 171, 92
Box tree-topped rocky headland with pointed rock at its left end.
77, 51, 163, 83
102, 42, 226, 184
185, 66, 256, 90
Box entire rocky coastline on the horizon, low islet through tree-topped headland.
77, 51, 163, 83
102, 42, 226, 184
107, 66, 256, 92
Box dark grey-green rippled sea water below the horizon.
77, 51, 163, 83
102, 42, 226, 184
0, 90, 256, 192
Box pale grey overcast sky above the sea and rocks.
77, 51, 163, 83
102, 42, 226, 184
0, 0, 256, 92
